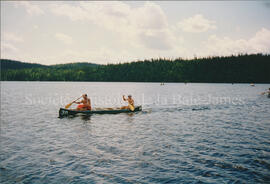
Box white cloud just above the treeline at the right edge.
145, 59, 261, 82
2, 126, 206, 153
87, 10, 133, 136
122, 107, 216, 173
198, 28, 270, 56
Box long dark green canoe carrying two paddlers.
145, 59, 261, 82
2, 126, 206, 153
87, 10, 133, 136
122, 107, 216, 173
59, 106, 142, 118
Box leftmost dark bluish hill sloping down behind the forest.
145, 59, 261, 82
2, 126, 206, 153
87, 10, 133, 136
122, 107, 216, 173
0, 59, 48, 70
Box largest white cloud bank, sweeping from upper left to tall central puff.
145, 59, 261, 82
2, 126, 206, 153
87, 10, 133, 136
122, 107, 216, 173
51, 1, 176, 50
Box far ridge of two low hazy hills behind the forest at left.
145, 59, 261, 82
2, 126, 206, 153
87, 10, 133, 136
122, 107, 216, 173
0, 59, 99, 70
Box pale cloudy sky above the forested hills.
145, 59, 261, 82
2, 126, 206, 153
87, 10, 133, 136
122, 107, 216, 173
1, 1, 270, 65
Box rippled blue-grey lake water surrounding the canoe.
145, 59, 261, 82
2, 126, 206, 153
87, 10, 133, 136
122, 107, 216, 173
0, 82, 270, 184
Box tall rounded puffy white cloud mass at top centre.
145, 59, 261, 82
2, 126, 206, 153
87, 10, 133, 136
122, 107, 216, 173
129, 2, 174, 50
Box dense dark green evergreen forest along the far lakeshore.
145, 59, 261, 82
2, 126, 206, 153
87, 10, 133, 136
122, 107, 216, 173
1, 54, 270, 83
